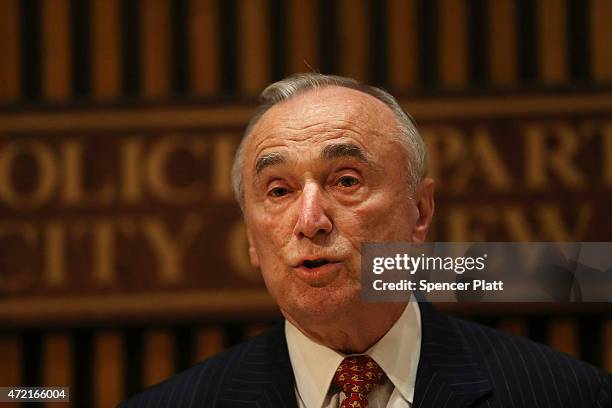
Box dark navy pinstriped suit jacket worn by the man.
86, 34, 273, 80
120, 303, 612, 408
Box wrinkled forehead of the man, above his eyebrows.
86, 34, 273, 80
246, 86, 397, 155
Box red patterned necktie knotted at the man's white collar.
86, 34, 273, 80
334, 356, 383, 408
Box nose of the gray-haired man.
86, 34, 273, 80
294, 182, 333, 239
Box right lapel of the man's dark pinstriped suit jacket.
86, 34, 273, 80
414, 302, 491, 408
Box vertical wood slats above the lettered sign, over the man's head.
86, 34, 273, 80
0, 0, 612, 105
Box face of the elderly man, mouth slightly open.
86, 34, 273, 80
242, 87, 433, 322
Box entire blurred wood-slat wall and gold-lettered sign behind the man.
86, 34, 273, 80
0, 0, 612, 407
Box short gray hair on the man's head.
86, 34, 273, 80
232, 73, 427, 209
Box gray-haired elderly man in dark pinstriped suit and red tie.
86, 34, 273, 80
123, 74, 612, 408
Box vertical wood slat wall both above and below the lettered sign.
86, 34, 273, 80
0, 0, 612, 407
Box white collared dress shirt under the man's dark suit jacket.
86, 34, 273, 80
285, 301, 421, 408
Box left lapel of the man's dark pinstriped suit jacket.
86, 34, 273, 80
219, 324, 297, 408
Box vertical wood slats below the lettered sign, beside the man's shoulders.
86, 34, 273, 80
0, 314, 612, 408
